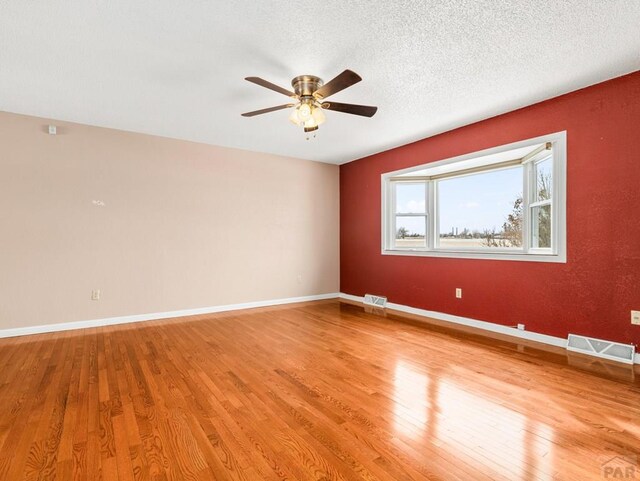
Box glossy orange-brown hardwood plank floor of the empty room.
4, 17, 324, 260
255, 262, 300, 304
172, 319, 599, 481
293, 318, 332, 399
0, 300, 640, 481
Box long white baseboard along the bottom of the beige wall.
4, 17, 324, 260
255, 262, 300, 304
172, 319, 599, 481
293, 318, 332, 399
0, 292, 340, 338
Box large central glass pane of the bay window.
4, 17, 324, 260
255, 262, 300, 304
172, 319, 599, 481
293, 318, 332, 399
437, 166, 523, 249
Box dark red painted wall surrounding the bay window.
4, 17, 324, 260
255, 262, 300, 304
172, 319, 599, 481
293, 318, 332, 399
340, 72, 640, 343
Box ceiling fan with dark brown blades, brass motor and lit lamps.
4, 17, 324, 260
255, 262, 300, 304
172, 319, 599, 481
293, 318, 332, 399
242, 70, 378, 132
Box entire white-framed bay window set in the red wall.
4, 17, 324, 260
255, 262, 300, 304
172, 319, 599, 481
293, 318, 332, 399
382, 132, 566, 262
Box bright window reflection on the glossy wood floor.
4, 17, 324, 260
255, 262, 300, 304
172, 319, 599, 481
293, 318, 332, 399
393, 360, 554, 480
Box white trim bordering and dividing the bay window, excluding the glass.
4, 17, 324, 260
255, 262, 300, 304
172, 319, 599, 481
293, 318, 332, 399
381, 131, 567, 263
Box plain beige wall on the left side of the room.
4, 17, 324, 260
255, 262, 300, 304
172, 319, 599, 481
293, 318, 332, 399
0, 112, 339, 329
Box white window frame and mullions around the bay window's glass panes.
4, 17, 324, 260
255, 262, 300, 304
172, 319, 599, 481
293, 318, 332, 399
381, 131, 567, 263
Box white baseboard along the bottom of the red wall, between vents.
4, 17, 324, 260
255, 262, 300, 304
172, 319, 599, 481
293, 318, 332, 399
340, 292, 640, 364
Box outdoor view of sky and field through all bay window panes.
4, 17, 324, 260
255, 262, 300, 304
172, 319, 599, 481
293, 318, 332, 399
395, 157, 552, 250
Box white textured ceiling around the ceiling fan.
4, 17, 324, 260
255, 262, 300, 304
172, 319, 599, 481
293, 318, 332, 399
0, 0, 640, 163
